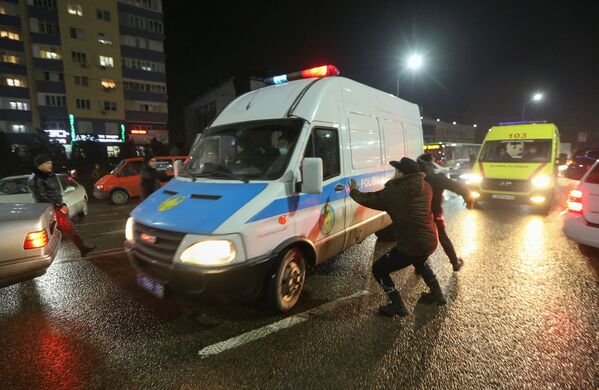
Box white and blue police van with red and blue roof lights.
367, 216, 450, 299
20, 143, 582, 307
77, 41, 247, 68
124, 65, 423, 312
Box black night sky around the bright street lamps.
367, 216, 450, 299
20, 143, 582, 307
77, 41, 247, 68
164, 0, 599, 142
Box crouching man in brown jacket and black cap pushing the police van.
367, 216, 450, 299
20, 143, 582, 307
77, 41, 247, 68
350, 157, 446, 317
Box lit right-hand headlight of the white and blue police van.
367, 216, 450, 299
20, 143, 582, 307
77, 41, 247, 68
181, 240, 237, 266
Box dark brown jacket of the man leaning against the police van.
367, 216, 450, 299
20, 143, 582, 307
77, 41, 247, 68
349, 172, 439, 256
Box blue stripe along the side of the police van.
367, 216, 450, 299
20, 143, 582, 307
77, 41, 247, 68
246, 169, 395, 223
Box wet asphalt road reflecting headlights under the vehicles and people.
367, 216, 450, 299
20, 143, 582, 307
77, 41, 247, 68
0, 184, 599, 389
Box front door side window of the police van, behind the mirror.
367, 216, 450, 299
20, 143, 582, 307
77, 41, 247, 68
304, 129, 341, 180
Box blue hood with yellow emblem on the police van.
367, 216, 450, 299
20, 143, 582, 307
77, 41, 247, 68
131, 179, 267, 234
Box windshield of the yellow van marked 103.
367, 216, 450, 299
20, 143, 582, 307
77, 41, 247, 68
479, 139, 551, 163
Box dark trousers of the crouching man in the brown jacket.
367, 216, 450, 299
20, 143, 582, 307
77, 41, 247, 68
372, 248, 437, 295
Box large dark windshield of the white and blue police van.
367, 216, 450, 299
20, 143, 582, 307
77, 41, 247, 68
181, 119, 304, 181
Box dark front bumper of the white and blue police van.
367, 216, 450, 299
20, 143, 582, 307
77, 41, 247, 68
124, 242, 277, 303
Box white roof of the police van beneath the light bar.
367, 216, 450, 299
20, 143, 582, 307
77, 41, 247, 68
212, 77, 420, 126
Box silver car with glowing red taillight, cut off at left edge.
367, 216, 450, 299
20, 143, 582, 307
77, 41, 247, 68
0, 203, 61, 287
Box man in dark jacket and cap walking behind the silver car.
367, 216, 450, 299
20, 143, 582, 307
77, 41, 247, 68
27, 154, 96, 257
